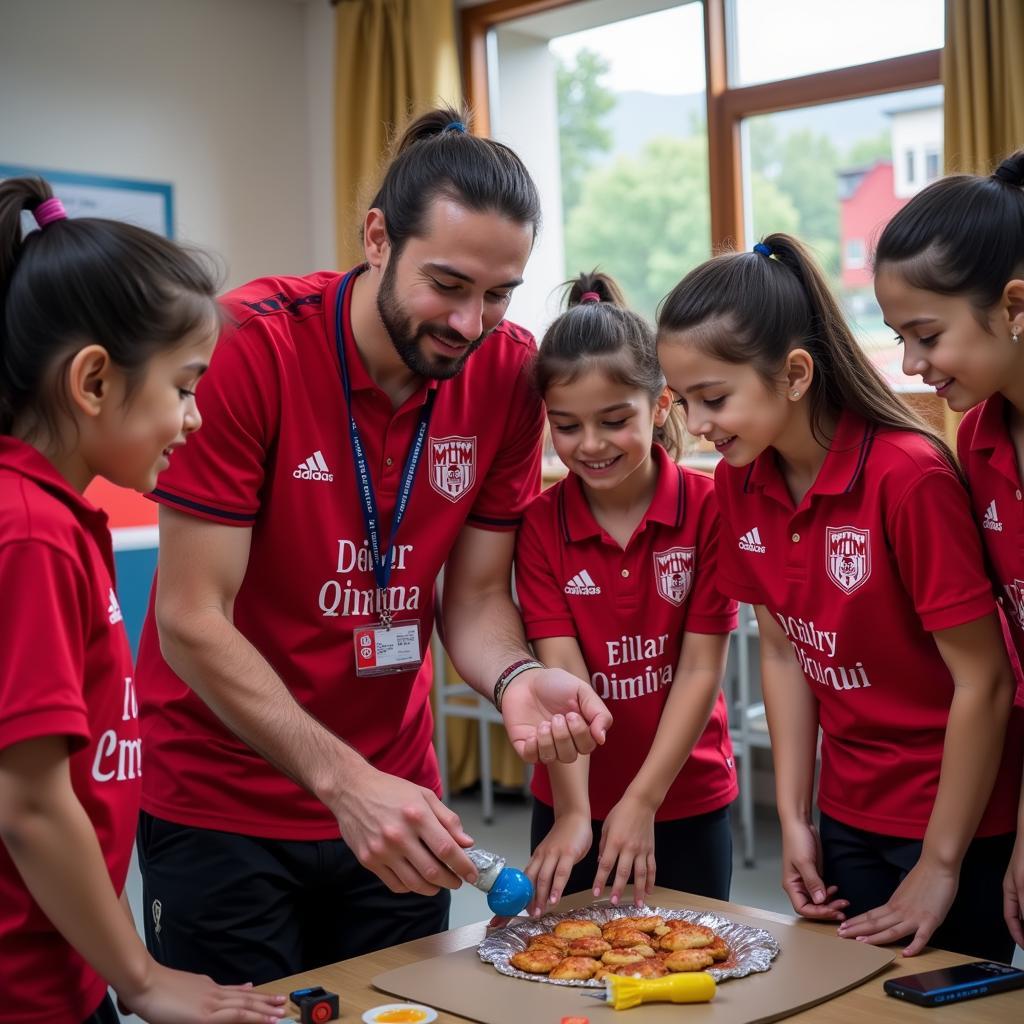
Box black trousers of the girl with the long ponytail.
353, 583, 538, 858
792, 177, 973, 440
820, 814, 1015, 964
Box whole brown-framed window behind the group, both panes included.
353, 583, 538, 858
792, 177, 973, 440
462, 0, 944, 388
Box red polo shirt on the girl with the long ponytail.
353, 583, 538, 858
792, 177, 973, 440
715, 414, 1020, 839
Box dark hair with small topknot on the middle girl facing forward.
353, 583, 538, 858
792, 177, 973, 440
534, 269, 683, 458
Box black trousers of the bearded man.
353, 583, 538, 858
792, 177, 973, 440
138, 812, 451, 985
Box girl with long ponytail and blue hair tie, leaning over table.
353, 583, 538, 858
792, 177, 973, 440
658, 234, 1019, 961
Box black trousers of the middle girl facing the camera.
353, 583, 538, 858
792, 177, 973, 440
529, 800, 732, 899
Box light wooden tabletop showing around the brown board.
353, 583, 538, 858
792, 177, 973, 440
260, 888, 1024, 1024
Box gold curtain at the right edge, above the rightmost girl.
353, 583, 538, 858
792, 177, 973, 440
942, 0, 1024, 174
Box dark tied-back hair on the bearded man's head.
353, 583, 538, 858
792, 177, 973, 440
370, 106, 541, 255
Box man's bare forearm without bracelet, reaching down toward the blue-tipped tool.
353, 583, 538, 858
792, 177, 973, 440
160, 609, 369, 807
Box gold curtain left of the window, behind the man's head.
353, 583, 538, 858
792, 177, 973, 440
335, 0, 462, 267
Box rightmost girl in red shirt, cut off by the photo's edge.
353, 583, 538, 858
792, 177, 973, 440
874, 150, 1024, 946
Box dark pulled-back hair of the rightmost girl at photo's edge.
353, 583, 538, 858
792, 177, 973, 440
874, 150, 1024, 309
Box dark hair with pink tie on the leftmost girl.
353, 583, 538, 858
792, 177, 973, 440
0, 178, 218, 434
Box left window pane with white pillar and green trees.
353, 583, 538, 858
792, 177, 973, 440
468, 0, 711, 333
